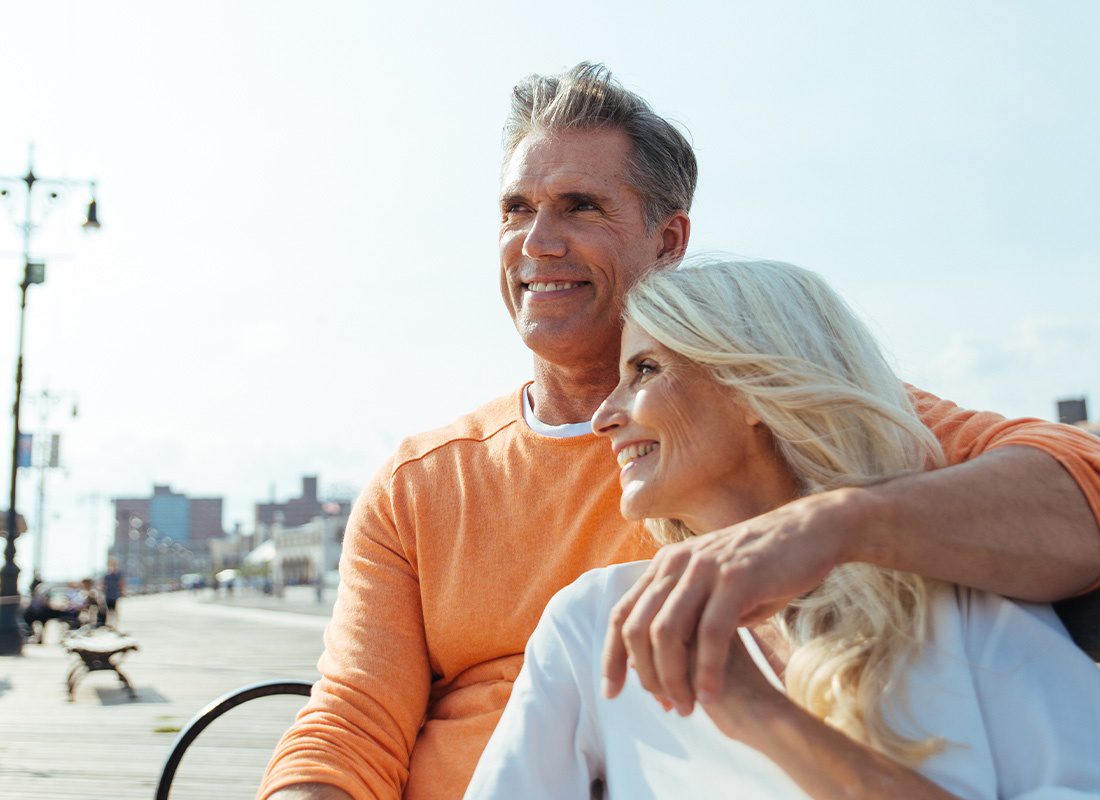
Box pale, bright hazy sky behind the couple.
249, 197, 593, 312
0, 0, 1100, 579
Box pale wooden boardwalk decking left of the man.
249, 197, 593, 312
0, 593, 326, 800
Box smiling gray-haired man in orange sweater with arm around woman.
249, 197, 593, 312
261, 64, 1100, 800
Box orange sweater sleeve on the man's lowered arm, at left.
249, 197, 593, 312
257, 465, 431, 800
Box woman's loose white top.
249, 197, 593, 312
465, 562, 1100, 800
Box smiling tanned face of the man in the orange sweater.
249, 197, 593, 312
499, 130, 685, 365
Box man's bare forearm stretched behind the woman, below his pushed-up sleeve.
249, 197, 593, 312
845, 447, 1100, 602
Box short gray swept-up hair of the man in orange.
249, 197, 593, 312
504, 62, 699, 229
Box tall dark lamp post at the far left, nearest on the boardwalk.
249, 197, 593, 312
0, 153, 99, 656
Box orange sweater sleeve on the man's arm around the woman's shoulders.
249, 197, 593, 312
908, 386, 1100, 585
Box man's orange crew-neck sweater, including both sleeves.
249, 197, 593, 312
260, 388, 1100, 800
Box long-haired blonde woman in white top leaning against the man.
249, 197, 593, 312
466, 262, 1100, 800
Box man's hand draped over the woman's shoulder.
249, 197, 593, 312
604, 490, 860, 714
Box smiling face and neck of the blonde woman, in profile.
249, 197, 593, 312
592, 321, 795, 534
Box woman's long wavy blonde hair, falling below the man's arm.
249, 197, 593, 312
626, 259, 944, 765
